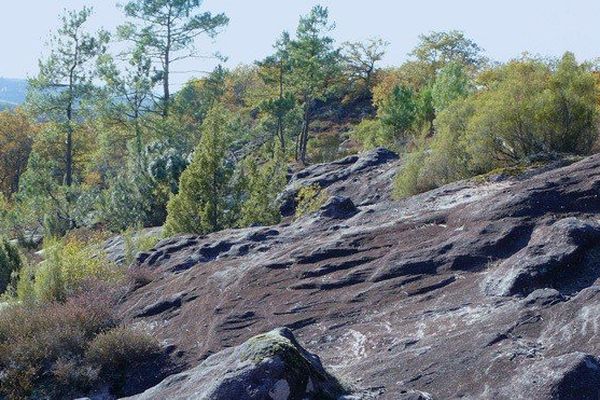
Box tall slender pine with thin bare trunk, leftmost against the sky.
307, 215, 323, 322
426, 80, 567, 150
28, 7, 109, 186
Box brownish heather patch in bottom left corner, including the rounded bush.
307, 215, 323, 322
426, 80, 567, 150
0, 282, 160, 399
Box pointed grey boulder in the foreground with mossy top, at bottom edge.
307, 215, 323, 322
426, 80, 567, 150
124, 328, 347, 400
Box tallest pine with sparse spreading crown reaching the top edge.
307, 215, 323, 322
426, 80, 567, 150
119, 0, 229, 117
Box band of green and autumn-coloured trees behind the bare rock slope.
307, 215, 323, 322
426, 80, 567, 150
0, 0, 598, 241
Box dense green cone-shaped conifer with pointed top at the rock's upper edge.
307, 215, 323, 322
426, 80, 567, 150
165, 106, 237, 235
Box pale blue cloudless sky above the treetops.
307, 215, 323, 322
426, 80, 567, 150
0, 0, 600, 86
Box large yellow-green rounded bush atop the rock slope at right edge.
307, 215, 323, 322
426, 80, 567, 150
396, 53, 598, 197
